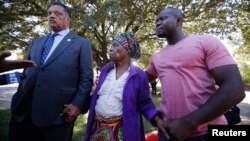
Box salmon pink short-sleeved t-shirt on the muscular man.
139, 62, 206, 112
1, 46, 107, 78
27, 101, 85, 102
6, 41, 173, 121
147, 35, 236, 136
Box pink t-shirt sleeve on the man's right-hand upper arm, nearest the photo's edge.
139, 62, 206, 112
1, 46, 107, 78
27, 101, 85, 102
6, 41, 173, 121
201, 35, 236, 69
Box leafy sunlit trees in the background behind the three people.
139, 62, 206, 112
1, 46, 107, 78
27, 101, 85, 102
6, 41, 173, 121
0, 0, 250, 85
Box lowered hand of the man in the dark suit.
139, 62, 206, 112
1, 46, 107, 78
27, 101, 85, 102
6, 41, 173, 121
61, 104, 81, 123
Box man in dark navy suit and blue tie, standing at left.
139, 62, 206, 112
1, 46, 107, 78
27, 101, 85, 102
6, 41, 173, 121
9, 2, 93, 141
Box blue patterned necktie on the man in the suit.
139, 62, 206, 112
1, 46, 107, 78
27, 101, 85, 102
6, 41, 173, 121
41, 33, 58, 65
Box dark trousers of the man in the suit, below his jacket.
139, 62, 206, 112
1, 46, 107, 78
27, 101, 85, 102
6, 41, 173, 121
9, 115, 74, 141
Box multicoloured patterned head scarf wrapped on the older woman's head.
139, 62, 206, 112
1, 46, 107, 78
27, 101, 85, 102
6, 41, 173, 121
114, 32, 141, 59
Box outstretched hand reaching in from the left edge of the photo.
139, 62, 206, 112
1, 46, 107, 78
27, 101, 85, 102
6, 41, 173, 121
0, 51, 36, 73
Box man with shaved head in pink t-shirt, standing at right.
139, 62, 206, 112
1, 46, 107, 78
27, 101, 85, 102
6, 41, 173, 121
146, 7, 245, 141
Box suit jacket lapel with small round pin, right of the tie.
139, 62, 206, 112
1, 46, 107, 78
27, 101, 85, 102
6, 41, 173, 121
43, 32, 75, 67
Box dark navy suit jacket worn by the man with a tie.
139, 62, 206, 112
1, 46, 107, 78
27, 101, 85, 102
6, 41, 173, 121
11, 32, 93, 126
